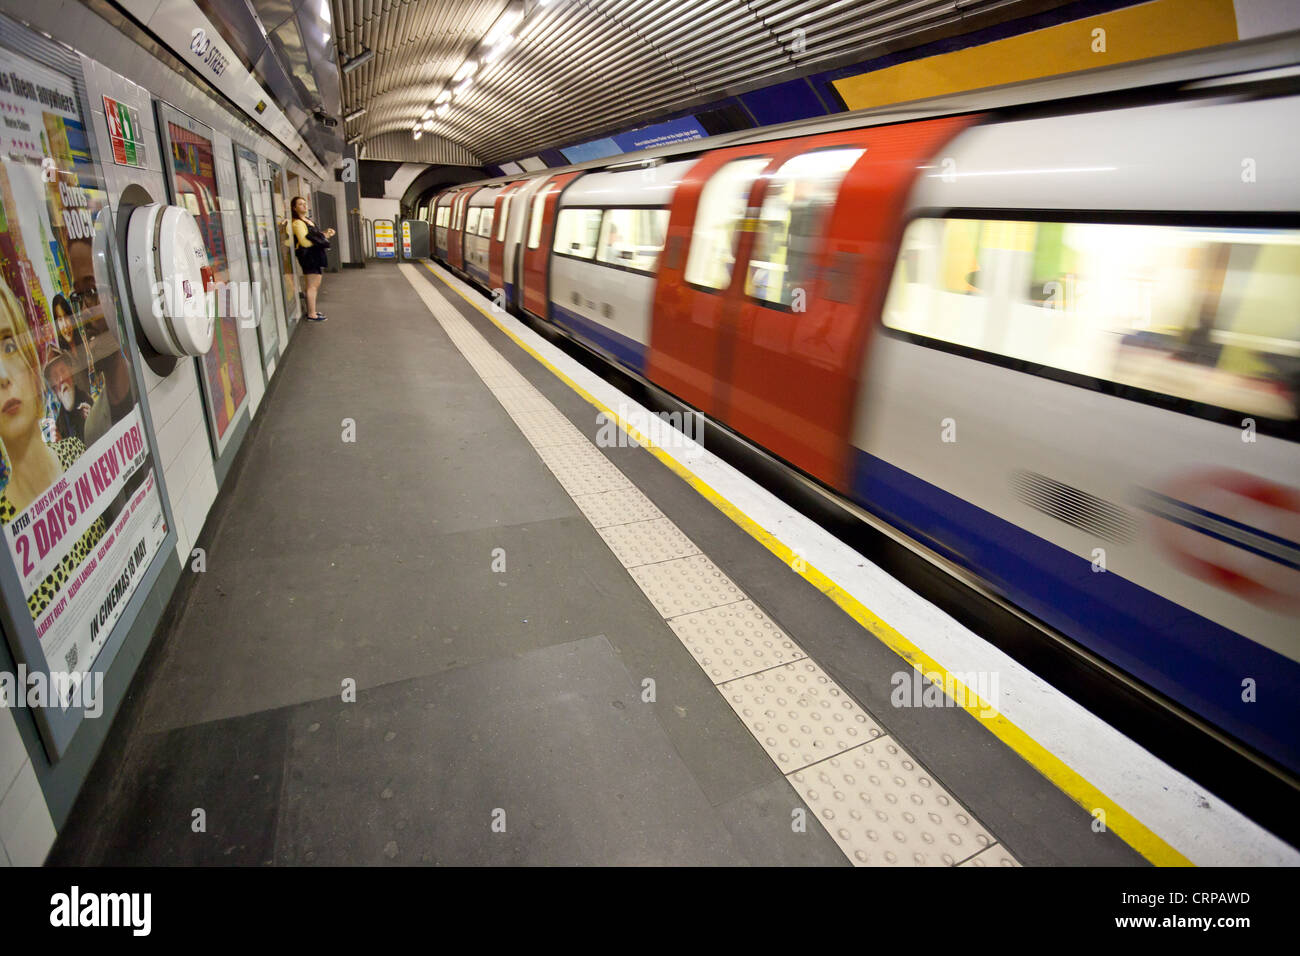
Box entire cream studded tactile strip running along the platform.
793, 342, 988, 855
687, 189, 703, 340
400, 265, 1019, 866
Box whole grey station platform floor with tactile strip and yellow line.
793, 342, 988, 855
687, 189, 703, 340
49, 264, 1294, 866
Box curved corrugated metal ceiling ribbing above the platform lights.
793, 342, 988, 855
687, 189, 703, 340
333, 0, 1056, 163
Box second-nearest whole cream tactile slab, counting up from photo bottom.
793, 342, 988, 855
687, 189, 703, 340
718, 658, 884, 774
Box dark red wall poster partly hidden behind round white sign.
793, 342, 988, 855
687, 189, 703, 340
166, 120, 247, 449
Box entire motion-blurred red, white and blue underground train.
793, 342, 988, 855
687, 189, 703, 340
429, 46, 1300, 771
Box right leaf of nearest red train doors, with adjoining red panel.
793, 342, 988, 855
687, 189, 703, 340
719, 117, 972, 488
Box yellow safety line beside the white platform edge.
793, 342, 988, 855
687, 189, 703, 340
424, 261, 1195, 866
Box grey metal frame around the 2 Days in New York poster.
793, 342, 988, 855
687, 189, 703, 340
0, 14, 177, 763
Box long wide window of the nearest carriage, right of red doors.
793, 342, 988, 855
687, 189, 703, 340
884, 219, 1300, 420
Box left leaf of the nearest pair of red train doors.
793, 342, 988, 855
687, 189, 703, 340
646, 143, 783, 415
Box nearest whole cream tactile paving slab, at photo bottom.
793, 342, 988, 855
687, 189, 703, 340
788, 739, 993, 866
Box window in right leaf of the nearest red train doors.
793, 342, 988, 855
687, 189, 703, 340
745, 147, 866, 306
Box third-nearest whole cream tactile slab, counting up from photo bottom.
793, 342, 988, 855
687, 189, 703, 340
670, 600, 807, 684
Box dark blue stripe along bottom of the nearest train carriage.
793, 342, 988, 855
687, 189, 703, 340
852, 449, 1300, 771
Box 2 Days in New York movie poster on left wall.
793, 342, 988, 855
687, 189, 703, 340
0, 42, 166, 705
